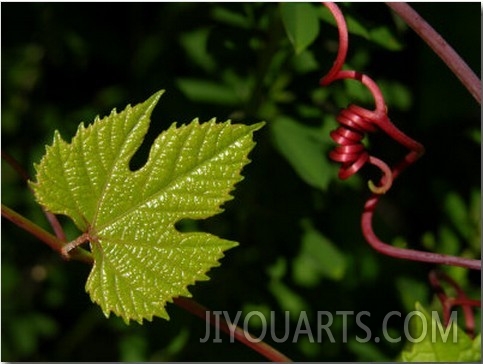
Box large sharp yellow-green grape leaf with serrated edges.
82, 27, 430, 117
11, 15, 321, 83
31, 91, 263, 323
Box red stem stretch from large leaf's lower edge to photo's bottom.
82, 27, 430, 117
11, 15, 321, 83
173, 297, 291, 362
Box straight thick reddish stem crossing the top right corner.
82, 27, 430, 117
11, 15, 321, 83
386, 2, 481, 104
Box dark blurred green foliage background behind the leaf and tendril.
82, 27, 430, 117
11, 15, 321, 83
1, 3, 481, 361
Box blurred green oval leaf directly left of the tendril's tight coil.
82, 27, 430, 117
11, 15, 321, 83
270, 117, 333, 190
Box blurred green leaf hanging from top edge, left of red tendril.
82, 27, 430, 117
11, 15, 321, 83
280, 2, 319, 54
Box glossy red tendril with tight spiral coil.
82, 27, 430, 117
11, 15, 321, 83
320, 3, 481, 270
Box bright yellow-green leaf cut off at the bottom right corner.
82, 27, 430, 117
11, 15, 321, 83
401, 302, 481, 362
